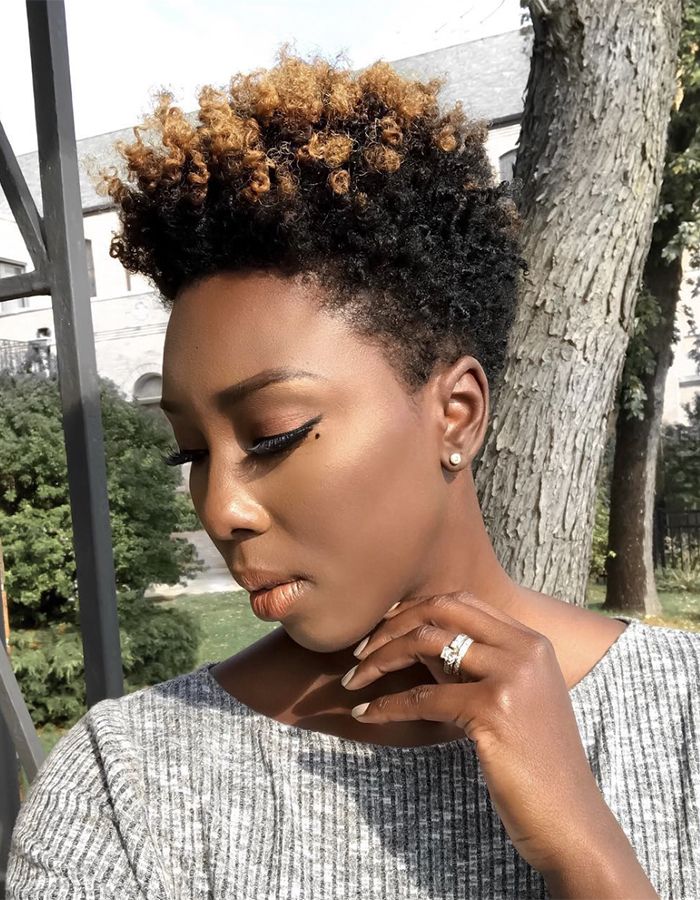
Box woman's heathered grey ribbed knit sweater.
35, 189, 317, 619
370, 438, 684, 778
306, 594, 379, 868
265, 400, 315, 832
7, 616, 700, 900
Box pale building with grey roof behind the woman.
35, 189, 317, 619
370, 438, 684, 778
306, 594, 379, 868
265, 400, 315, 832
0, 30, 700, 426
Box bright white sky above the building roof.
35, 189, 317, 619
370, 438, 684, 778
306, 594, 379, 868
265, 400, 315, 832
0, 0, 522, 155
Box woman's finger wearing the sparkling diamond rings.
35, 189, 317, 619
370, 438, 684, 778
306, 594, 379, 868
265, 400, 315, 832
343, 624, 505, 691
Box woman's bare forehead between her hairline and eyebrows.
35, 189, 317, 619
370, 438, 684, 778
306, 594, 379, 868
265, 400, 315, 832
163, 273, 388, 393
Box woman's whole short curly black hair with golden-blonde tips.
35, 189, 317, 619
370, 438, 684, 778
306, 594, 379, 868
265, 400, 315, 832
97, 46, 525, 391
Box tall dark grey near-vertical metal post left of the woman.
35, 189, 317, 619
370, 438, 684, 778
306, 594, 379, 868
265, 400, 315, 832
27, 0, 124, 706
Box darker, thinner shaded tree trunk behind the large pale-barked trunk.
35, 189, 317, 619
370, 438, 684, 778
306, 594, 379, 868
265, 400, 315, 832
603, 243, 683, 616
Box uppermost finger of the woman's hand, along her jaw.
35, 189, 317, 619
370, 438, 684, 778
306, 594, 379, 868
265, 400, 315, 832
355, 593, 529, 659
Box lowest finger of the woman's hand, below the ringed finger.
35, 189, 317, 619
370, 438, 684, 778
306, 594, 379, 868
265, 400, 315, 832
352, 681, 484, 740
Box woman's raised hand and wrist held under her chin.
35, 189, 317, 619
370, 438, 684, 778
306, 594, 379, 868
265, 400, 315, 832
345, 592, 621, 873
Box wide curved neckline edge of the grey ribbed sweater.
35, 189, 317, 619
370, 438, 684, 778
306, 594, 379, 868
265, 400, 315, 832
193, 615, 644, 757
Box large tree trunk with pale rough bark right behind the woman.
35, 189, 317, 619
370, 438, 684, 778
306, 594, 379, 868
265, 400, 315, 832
476, 0, 681, 605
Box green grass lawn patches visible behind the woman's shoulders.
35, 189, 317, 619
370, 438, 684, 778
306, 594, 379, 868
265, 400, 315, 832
39, 584, 700, 753
